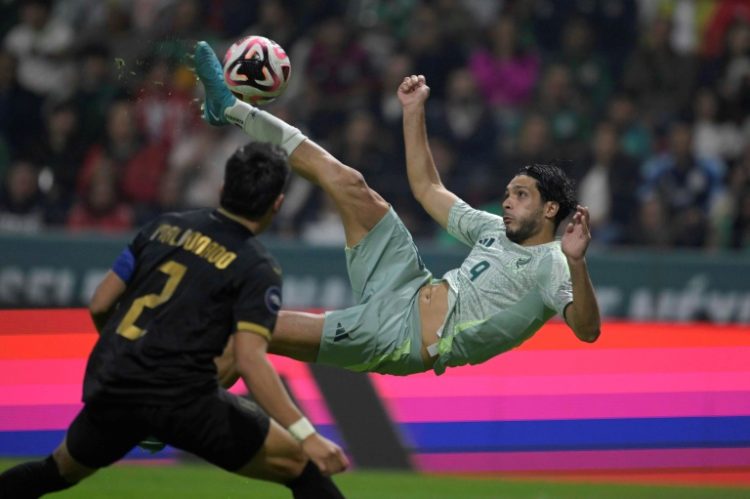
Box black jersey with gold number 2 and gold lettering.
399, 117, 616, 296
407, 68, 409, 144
83, 209, 281, 403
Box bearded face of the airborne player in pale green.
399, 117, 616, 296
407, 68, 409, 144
503, 175, 544, 244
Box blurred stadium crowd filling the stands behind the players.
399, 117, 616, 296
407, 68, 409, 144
0, 0, 750, 251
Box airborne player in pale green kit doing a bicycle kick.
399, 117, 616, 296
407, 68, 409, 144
195, 42, 600, 375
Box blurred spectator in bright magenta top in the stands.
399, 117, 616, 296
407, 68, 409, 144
470, 16, 539, 107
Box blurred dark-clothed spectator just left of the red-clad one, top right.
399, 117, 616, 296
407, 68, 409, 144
623, 17, 695, 125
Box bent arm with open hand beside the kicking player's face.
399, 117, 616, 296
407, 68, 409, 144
562, 206, 601, 343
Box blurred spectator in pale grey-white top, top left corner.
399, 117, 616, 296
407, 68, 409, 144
4, 0, 74, 96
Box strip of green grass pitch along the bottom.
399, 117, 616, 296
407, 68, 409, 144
0, 459, 750, 499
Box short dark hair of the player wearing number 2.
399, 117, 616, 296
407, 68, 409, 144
219, 142, 289, 220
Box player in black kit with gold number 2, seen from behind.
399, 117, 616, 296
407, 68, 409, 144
0, 143, 348, 498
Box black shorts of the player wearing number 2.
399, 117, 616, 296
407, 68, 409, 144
66, 390, 270, 471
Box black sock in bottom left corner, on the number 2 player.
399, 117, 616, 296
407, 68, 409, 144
0, 456, 75, 499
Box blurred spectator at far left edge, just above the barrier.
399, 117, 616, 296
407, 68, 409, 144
0, 160, 47, 232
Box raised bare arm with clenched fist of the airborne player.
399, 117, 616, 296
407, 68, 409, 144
398, 75, 458, 228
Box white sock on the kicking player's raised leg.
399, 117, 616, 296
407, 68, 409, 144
224, 99, 307, 155
